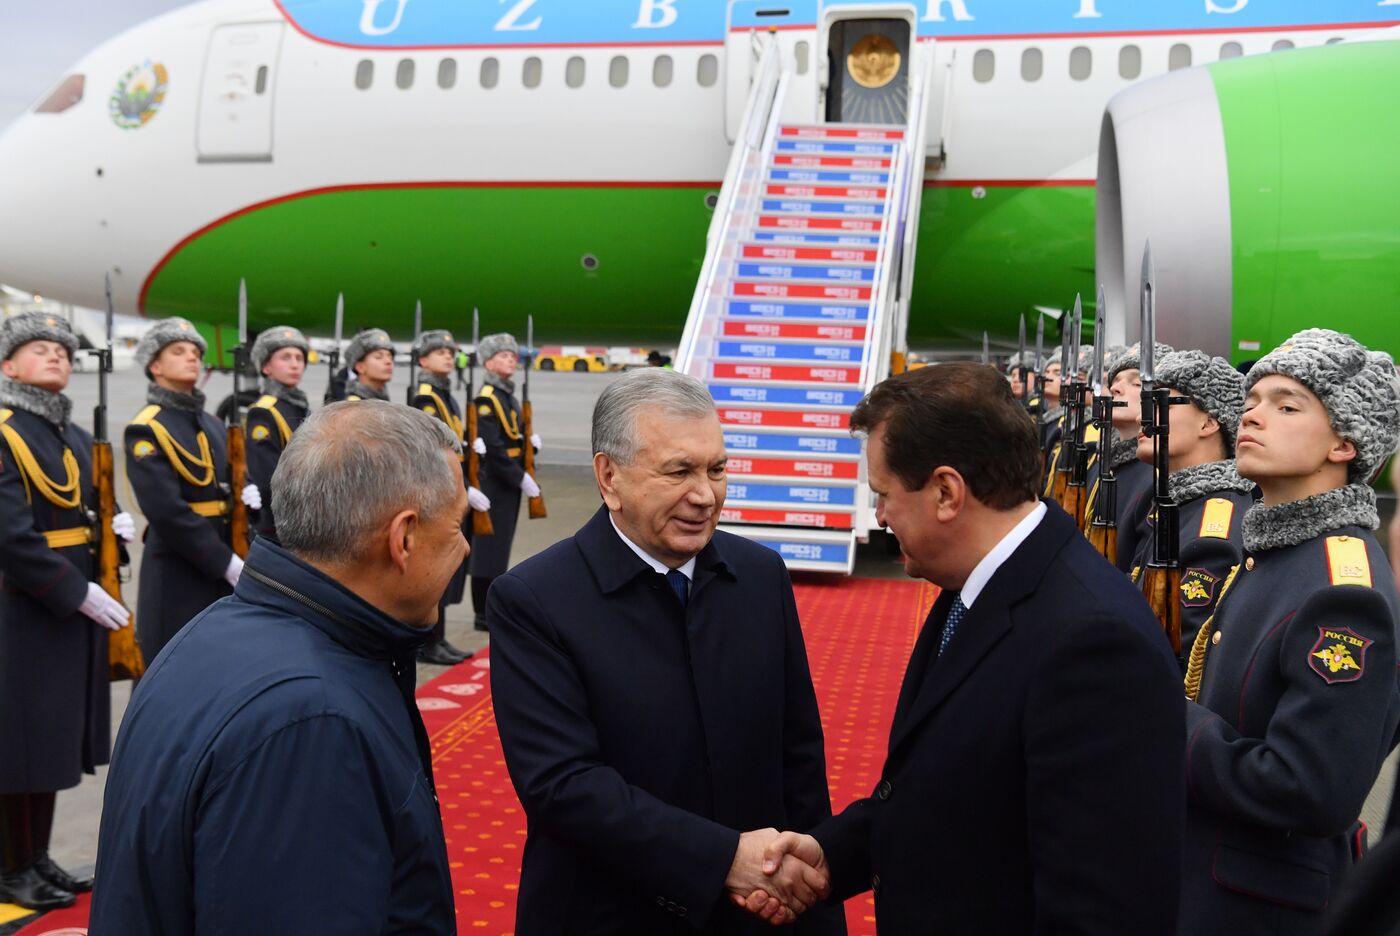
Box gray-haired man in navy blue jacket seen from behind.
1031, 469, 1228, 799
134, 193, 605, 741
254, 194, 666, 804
91, 402, 468, 936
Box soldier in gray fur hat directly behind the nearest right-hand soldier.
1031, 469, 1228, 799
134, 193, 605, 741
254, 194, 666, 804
1131, 351, 1254, 659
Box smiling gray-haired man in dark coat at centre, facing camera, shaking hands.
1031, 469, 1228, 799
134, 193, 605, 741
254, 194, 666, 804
486, 368, 840, 936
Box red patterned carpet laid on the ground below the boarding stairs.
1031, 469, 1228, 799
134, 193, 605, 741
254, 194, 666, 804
20, 576, 937, 936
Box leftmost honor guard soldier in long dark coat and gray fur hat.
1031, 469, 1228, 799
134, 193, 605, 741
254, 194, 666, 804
0, 312, 134, 911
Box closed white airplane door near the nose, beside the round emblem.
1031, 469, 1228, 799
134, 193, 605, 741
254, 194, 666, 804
196, 22, 283, 162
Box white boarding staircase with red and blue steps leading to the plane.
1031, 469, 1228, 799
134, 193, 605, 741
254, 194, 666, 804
676, 46, 931, 575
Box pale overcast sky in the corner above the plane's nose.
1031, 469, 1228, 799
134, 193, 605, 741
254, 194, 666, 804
0, 0, 190, 129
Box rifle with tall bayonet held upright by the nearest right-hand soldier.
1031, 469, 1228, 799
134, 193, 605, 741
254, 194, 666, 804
1138, 243, 1189, 653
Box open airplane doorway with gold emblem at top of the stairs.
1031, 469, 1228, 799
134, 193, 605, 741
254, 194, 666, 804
826, 18, 911, 123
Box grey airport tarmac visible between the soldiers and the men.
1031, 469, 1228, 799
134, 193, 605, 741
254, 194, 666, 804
32, 355, 1396, 869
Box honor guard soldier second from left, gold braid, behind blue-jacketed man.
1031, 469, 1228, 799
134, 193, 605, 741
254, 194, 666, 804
125, 318, 260, 663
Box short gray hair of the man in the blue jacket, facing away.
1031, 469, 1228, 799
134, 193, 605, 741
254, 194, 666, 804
272, 400, 462, 562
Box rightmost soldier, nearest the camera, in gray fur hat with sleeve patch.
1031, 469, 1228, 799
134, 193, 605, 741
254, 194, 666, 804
1180, 329, 1400, 936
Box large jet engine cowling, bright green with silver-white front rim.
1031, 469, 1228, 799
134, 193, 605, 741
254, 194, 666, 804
1095, 38, 1400, 362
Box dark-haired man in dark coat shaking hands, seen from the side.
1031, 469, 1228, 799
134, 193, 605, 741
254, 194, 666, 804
749, 364, 1184, 936
